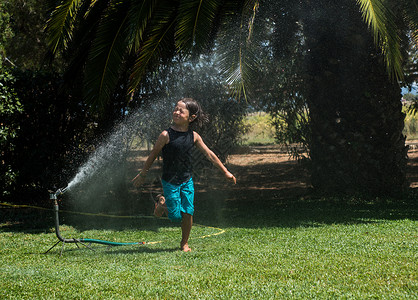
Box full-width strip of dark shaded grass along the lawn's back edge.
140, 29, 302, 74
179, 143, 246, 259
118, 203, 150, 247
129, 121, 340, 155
0, 189, 418, 234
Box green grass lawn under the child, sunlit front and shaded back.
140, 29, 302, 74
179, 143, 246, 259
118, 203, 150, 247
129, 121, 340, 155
0, 199, 418, 299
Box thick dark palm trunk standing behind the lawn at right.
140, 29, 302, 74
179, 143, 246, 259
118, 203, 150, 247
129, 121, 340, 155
304, 0, 407, 196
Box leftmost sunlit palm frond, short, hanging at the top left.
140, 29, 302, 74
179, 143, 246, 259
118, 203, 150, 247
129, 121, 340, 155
45, 0, 84, 53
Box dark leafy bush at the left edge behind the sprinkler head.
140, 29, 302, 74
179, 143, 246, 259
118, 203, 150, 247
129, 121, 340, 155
0, 70, 96, 202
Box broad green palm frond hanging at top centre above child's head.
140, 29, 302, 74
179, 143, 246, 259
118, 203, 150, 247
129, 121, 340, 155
175, 0, 222, 53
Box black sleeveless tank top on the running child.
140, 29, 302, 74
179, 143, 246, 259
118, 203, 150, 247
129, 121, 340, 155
162, 127, 194, 184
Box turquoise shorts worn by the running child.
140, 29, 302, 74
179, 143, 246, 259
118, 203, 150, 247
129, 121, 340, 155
162, 178, 194, 222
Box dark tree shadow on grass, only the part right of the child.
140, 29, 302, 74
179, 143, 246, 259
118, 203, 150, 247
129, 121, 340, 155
195, 195, 418, 228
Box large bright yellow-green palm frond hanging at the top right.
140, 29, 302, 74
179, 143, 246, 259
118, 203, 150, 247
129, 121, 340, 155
356, 0, 403, 81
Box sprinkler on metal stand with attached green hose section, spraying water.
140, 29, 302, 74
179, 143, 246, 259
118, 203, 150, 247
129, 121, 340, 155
44, 186, 146, 256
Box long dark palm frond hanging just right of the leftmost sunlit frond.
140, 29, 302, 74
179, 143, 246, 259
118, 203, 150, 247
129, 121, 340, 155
84, 0, 129, 108
